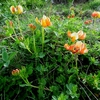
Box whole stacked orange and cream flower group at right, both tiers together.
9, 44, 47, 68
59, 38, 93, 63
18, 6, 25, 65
64, 30, 88, 54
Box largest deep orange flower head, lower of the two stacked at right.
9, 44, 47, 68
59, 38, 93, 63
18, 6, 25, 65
64, 41, 88, 54
